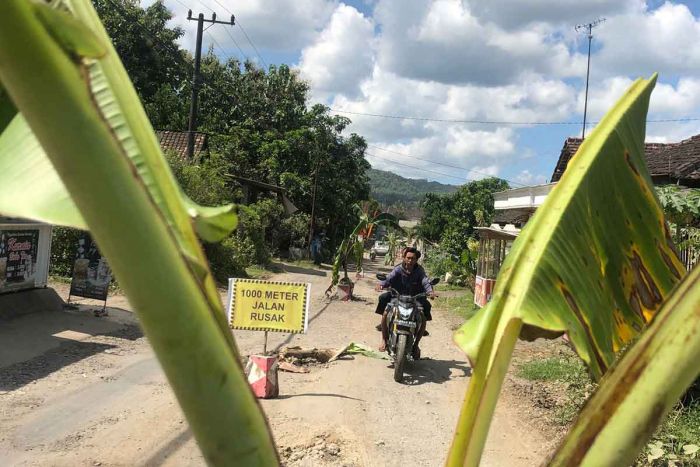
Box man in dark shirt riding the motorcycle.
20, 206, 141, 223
375, 247, 437, 358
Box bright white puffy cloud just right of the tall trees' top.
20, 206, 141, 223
299, 5, 374, 97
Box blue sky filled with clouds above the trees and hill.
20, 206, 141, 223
156, 0, 700, 186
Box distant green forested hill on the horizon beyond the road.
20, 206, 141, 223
369, 169, 459, 218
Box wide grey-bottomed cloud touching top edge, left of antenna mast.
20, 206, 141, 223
375, 0, 582, 85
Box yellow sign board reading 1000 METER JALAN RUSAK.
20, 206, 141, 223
226, 279, 311, 333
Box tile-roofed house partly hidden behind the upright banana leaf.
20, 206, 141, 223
474, 135, 700, 306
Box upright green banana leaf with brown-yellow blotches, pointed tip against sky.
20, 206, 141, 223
448, 75, 685, 465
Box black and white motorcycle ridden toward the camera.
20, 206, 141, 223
377, 274, 440, 383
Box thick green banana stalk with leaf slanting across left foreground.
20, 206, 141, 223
0, 0, 279, 466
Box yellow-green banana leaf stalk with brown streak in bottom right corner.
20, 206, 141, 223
550, 262, 700, 466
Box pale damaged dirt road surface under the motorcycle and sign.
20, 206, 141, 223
0, 265, 550, 466
